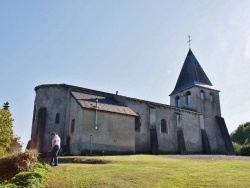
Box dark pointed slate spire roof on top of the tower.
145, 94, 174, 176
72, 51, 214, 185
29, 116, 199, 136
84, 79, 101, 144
170, 49, 213, 95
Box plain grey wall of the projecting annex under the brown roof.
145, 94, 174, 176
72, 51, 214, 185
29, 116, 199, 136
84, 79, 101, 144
69, 98, 135, 155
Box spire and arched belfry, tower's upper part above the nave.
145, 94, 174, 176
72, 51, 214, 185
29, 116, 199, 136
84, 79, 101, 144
170, 49, 221, 117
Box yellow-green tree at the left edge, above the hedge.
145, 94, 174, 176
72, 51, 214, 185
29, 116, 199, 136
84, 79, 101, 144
0, 102, 13, 156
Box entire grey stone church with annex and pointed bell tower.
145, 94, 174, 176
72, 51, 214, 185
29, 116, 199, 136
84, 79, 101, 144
31, 49, 234, 155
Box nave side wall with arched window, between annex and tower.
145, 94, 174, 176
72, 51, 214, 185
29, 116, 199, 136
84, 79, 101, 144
115, 96, 202, 154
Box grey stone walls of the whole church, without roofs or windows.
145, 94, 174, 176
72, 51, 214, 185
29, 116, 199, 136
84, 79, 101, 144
31, 84, 229, 155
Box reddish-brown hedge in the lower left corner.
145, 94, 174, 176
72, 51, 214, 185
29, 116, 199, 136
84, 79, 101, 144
0, 150, 38, 180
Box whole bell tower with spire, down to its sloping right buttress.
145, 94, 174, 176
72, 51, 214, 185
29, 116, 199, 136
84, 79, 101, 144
170, 48, 234, 154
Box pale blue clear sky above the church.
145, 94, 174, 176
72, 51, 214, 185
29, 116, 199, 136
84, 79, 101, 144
0, 0, 250, 146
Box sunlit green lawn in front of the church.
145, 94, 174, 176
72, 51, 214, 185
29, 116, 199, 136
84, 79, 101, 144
42, 155, 250, 188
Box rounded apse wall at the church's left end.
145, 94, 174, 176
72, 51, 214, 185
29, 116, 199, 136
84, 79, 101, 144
31, 86, 69, 152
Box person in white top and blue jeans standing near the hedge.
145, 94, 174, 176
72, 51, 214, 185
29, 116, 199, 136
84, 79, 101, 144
50, 132, 61, 166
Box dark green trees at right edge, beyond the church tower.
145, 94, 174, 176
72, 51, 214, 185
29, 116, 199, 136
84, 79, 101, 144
230, 122, 250, 156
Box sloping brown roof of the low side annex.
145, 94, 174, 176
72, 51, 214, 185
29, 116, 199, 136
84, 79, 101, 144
71, 92, 138, 116
